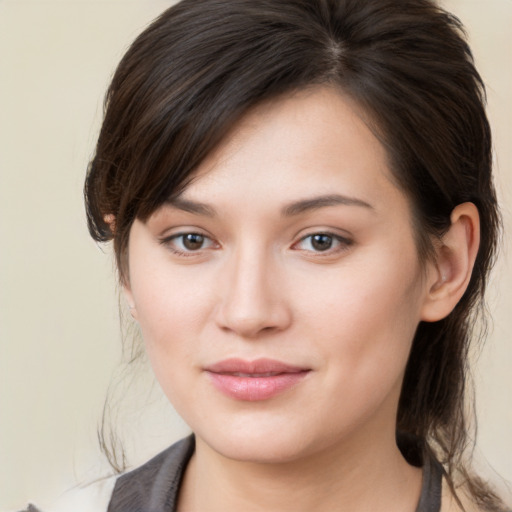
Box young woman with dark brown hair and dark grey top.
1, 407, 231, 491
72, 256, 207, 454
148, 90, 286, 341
22, 0, 504, 512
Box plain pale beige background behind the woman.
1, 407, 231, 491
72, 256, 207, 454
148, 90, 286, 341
0, 0, 512, 510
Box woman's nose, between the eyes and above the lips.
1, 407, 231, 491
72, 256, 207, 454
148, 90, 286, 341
213, 246, 292, 339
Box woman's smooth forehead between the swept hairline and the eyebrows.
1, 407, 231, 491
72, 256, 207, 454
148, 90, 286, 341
174, 87, 404, 218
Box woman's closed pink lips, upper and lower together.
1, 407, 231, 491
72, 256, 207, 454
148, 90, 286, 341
205, 359, 310, 402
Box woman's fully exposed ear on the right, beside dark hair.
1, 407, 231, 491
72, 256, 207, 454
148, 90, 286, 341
421, 203, 480, 322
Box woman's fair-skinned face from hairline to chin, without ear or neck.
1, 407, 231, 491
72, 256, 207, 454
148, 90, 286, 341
126, 88, 427, 461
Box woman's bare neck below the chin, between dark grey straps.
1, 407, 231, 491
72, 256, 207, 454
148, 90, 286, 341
179, 420, 421, 512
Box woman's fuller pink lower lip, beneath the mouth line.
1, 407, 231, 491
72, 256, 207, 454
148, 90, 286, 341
207, 370, 309, 402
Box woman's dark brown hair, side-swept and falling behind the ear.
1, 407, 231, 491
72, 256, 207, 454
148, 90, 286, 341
85, 0, 500, 510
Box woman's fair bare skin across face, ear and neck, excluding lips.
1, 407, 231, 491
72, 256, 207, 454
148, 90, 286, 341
125, 88, 478, 512
